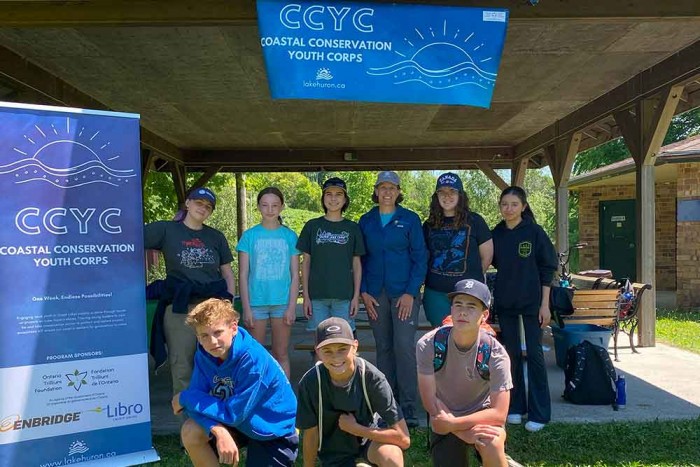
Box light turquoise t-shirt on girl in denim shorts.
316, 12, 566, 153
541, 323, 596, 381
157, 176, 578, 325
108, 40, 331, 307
236, 224, 299, 306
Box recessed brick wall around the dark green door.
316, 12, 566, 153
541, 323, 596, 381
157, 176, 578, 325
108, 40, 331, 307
579, 182, 676, 290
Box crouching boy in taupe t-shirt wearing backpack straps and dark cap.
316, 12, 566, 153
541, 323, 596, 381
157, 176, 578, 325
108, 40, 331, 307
416, 279, 513, 467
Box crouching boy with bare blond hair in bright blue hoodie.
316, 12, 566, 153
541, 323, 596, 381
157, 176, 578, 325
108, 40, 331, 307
172, 298, 299, 467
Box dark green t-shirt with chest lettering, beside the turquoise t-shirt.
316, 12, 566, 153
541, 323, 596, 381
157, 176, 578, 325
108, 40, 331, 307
297, 217, 365, 300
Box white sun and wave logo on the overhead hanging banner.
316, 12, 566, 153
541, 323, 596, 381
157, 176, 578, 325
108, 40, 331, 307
367, 20, 497, 90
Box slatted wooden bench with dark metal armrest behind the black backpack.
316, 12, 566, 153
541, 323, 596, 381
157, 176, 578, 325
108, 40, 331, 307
561, 274, 651, 362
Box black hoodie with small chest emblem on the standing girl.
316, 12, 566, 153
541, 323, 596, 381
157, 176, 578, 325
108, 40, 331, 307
492, 217, 557, 315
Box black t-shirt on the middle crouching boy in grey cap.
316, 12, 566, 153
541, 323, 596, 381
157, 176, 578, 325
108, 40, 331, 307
297, 357, 403, 465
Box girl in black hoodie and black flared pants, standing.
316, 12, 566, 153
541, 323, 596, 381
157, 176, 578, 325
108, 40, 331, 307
492, 186, 557, 431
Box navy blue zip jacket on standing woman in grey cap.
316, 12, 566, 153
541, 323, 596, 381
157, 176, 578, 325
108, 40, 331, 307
360, 206, 428, 298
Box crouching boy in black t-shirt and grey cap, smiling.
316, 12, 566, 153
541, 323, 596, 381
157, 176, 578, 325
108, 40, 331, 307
297, 318, 410, 467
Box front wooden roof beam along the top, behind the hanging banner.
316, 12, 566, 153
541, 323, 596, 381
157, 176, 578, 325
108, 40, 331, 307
0, 0, 697, 27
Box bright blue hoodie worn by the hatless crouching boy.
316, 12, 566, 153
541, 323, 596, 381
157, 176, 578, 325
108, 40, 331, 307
180, 327, 297, 441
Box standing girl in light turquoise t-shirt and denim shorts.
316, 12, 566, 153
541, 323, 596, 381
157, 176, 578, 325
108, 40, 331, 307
237, 187, 299, 378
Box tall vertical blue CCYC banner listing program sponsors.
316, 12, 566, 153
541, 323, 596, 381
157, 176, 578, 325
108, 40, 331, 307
0, 103, 158, 467
